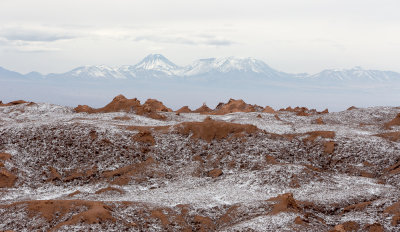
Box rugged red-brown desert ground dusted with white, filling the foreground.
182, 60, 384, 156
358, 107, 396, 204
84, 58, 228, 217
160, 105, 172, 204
0, 95, 400, 232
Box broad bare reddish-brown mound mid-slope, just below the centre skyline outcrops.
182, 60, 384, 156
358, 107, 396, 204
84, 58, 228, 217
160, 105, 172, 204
176, 117, 258, 142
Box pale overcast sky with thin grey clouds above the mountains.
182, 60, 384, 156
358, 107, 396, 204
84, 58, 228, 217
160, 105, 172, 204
0, 0, 400, 73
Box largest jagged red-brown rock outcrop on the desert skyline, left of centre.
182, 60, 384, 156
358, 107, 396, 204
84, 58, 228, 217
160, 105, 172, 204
74, 95, 172, 120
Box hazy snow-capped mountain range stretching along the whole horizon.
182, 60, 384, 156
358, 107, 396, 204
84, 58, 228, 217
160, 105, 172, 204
0, 54, 400, 82
